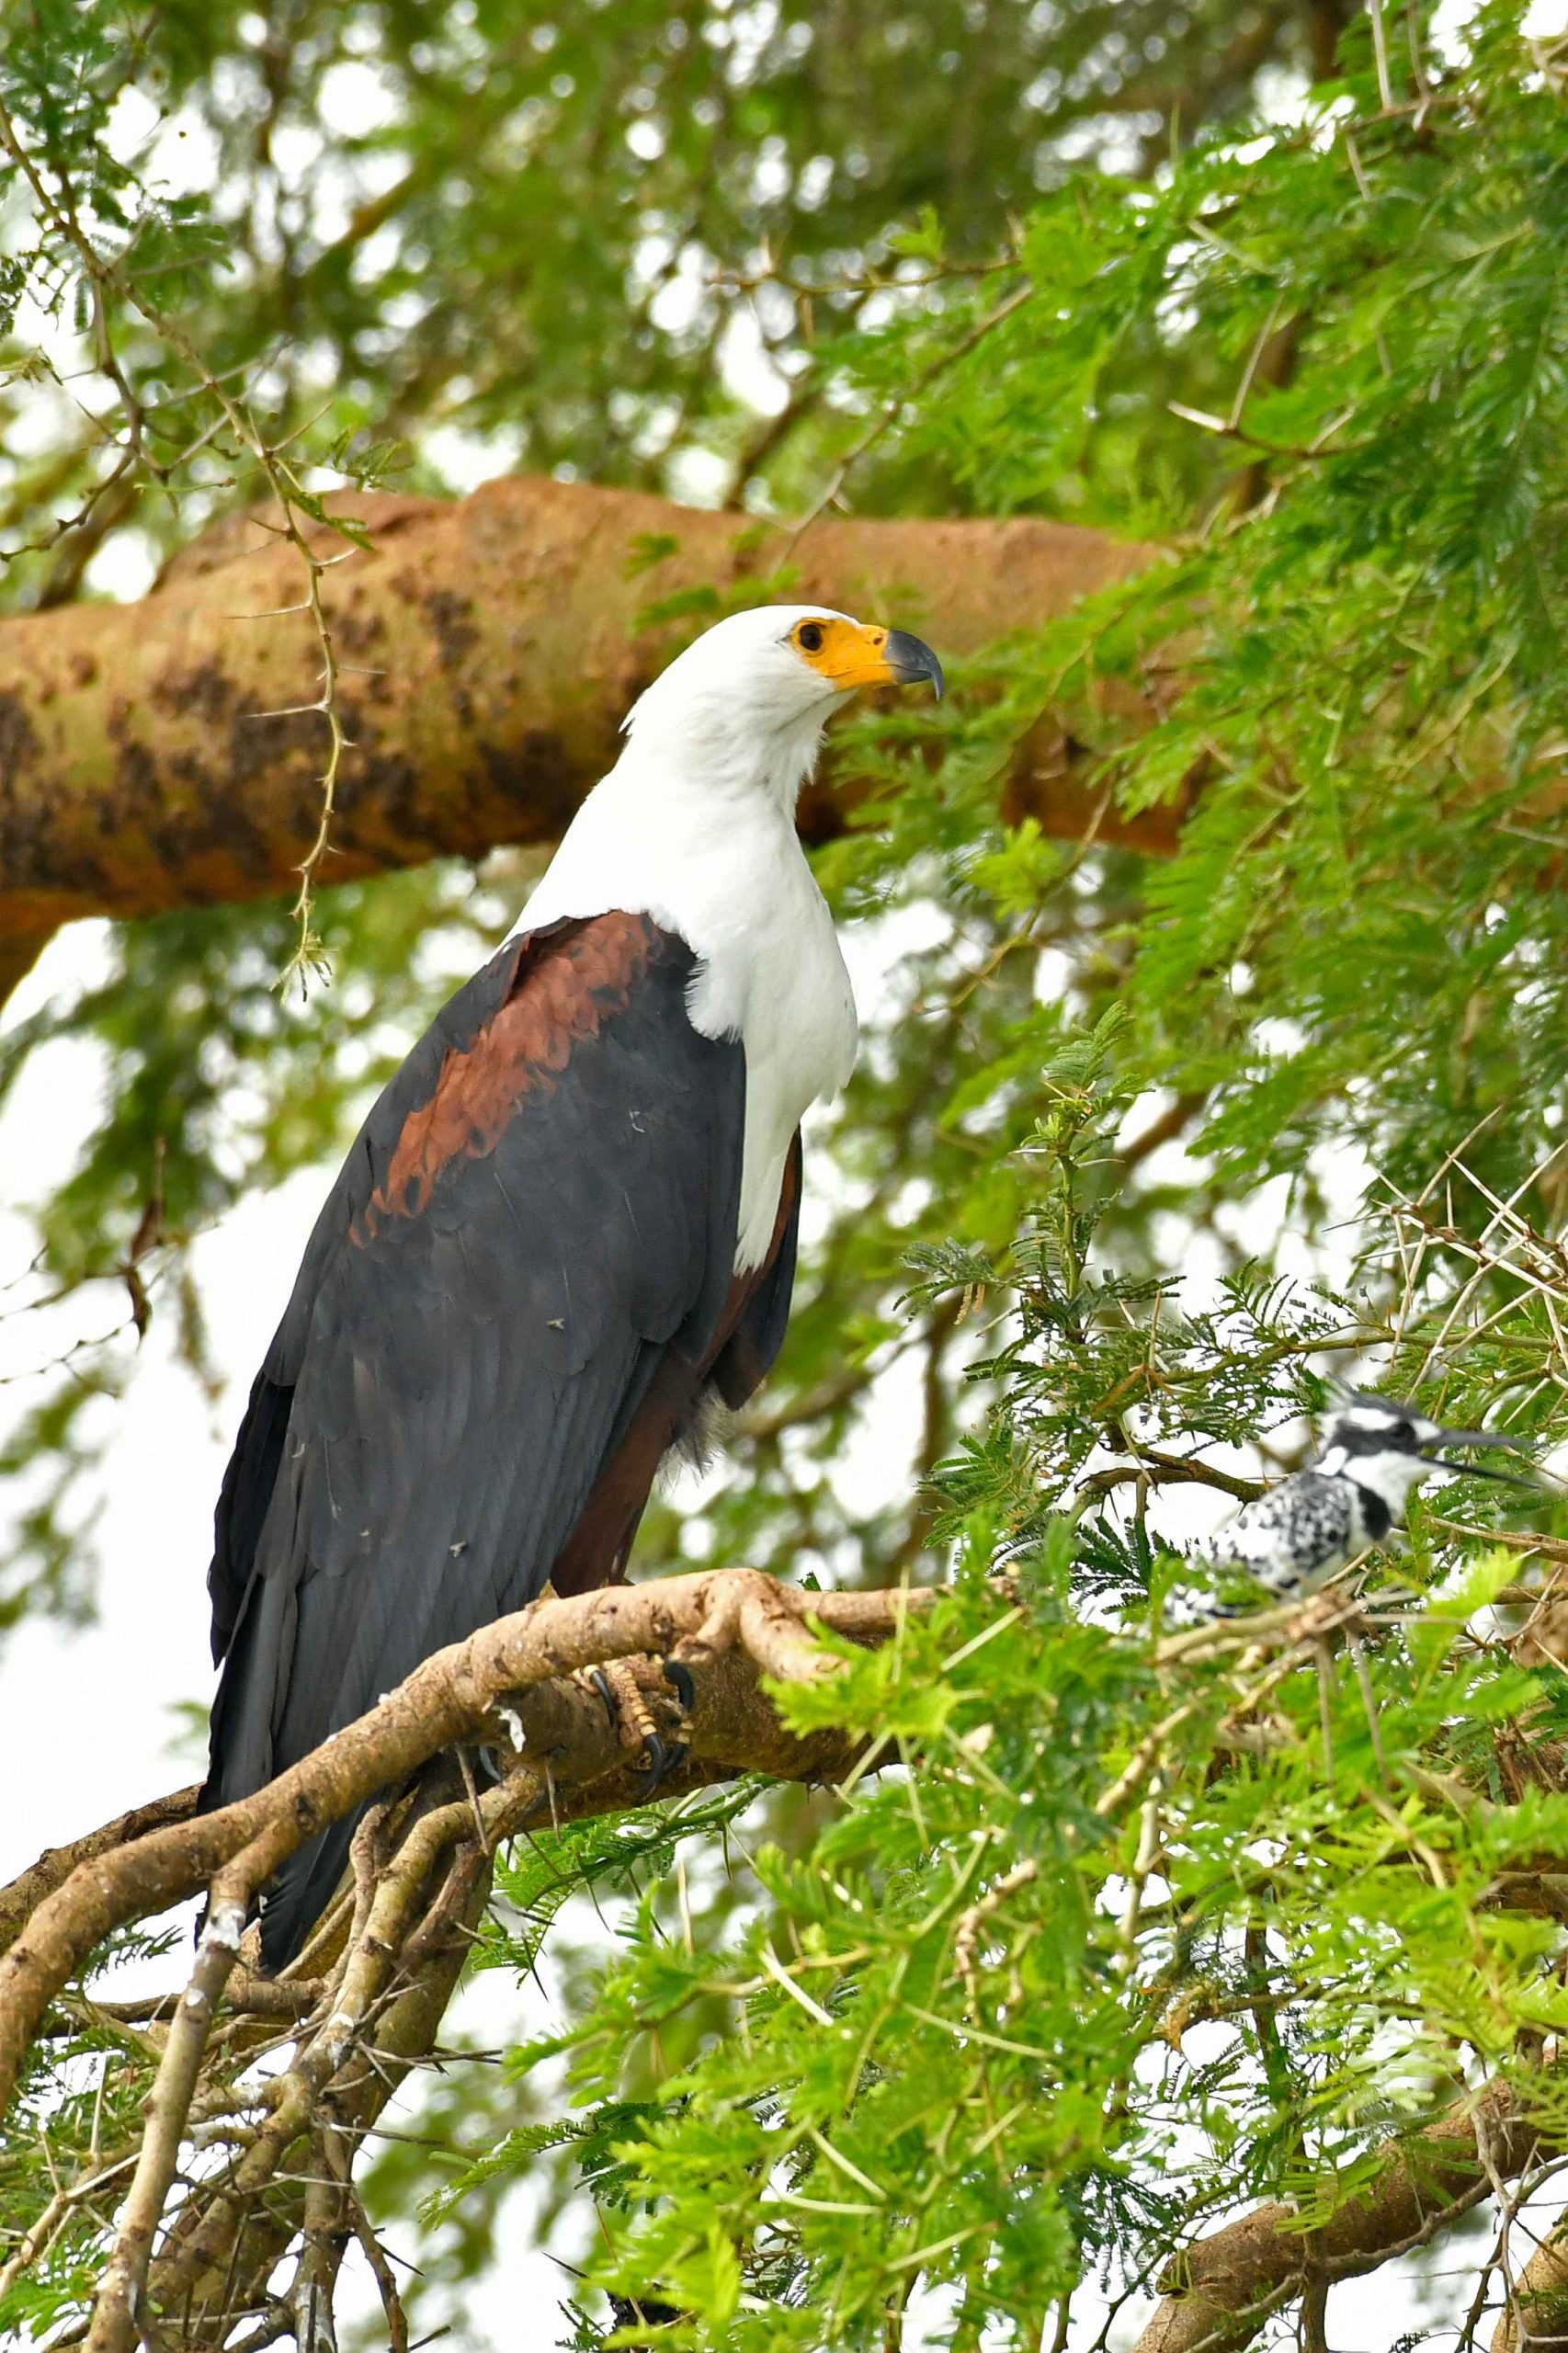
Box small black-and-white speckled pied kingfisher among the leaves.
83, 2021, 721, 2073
1191, 1395, 1528, 1596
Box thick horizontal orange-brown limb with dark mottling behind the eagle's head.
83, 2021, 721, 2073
0, 480, 1158, 995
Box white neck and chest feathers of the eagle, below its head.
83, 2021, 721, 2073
516, 753, 857, 1273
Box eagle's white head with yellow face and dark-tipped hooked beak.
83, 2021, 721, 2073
624, 605, 942, 802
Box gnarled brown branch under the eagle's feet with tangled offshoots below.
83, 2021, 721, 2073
0, 1570, 950, 2353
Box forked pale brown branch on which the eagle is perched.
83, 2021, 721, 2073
0, 1570, 932, 2353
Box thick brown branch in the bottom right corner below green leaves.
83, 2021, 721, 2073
1132, 2085, 1542, 2353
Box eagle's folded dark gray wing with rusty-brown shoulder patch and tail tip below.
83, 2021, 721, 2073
205, 913, 753, 1965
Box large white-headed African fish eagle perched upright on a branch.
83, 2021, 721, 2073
202, 605, 942, 1967
